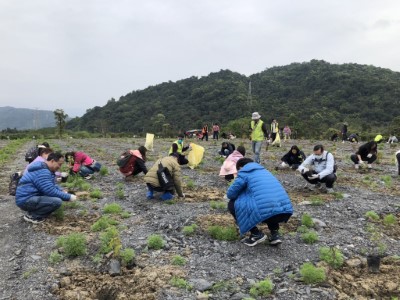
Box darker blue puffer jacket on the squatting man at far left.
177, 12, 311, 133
15, 162, 71, 206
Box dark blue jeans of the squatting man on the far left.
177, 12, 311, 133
20, 196, 62, 219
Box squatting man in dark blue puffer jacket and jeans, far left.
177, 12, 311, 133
15, 153, 77, 224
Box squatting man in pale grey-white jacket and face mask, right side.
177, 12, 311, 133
297, 145, 336, 193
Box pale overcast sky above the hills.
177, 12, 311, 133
0, 0, 400, 117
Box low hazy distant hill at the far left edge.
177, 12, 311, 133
0, 106, 55, 130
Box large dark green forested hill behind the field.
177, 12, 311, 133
67, 60, 400, 137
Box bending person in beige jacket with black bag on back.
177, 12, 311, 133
144, 152, 185, 200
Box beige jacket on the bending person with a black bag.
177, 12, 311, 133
144, 156, 183, 197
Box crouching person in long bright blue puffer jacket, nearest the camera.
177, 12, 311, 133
227, 158, 293, 247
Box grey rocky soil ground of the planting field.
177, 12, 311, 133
0, 138, 400, 299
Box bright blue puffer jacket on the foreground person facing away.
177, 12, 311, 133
227, 163, 293, 235
